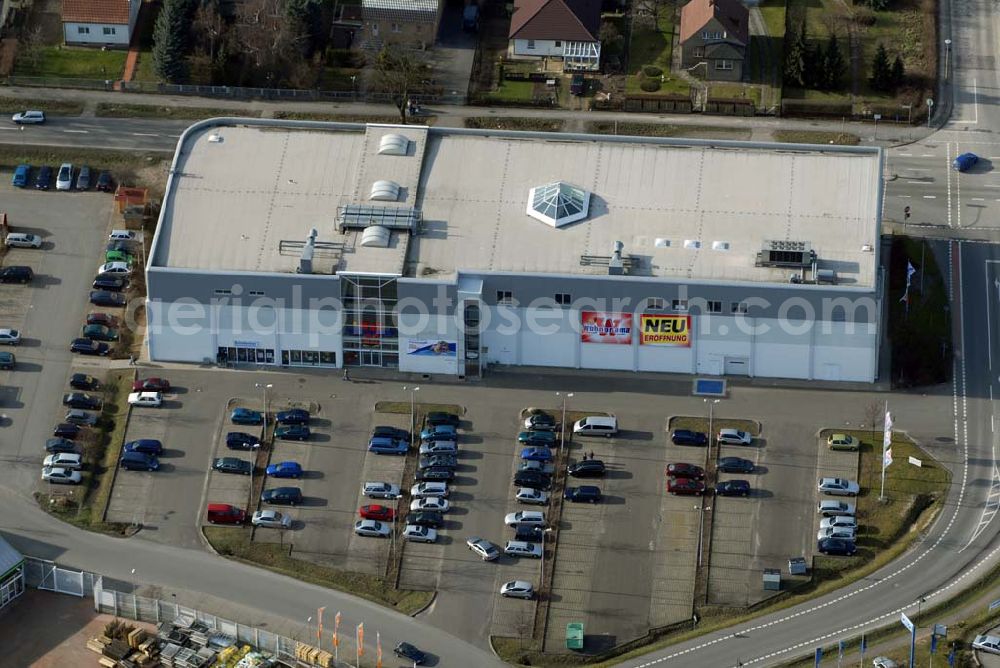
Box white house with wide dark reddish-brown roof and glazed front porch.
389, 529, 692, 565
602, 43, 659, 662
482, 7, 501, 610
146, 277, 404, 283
507, 0, 601, 70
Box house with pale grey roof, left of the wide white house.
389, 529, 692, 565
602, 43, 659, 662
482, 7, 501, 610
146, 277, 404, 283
355, 0, 444, 50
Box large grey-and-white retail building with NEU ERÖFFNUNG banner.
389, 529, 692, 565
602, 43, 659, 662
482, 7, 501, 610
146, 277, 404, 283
146, 119, 884, 381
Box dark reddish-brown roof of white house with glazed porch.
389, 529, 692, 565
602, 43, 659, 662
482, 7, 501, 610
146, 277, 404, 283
508, 0, 601, 42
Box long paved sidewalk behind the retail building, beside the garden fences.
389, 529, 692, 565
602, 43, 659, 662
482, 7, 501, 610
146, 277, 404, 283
2, 86, 937, 146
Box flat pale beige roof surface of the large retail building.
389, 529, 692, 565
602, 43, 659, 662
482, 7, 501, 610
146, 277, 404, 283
153, 125, 881, 287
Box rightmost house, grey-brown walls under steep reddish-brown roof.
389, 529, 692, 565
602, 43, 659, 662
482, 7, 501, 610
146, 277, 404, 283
680, 0, 750, 81
